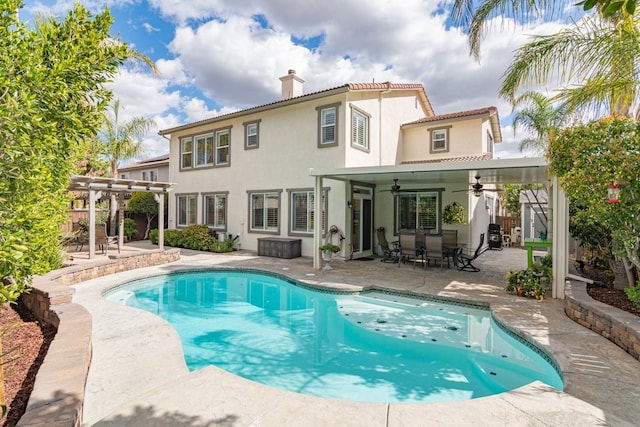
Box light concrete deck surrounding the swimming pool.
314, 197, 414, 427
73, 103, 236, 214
74, 248, 640, 426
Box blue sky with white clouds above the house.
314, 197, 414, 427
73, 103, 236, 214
20, 0, 572, 158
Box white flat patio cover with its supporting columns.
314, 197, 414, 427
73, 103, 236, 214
309, 158, 569, 298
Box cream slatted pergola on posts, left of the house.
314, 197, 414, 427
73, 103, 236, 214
68, 175, 173, 259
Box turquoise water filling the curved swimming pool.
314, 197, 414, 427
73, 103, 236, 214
105, 269, 563, 402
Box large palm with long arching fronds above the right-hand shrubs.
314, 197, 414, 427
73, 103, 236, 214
500, 14, 640, 117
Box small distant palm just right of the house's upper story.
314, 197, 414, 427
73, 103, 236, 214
513, 91, 564, 155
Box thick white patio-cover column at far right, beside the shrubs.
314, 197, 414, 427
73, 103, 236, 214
551, 176, 569, 299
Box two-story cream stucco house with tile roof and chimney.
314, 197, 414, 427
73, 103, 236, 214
160, 70, 502, 259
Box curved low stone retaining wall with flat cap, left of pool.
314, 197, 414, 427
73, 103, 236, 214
18, 248, 180, 427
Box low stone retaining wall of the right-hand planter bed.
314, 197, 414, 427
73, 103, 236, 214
564, 281, 640, 360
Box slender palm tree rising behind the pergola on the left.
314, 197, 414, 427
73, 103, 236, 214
99, 99, 154, 234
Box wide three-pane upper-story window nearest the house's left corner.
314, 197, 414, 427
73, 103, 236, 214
180, 128, 231, 169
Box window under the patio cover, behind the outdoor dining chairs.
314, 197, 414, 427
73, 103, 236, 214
396, 191, 440, 233
